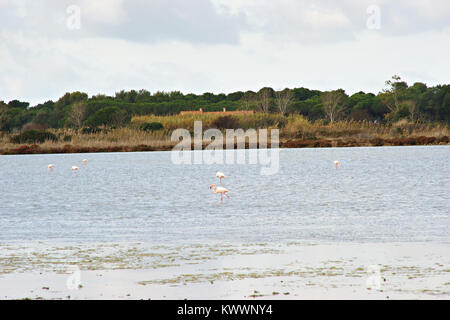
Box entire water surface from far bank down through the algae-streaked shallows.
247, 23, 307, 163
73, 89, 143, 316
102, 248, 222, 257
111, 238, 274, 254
0, 146, 450, 299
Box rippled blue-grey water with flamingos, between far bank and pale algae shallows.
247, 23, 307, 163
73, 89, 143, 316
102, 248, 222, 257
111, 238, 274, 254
0, 146, 450, 243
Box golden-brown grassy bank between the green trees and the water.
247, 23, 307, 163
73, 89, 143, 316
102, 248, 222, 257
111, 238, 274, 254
0, 114, 450, 154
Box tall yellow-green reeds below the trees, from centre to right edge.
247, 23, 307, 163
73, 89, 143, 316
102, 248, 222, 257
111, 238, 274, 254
131, 113, 450, 139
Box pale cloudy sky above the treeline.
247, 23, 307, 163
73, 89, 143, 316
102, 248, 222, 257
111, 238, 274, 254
0, 0, 450, 105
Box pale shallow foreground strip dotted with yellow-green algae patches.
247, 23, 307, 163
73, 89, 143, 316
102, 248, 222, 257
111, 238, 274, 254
0, 242, 450, 299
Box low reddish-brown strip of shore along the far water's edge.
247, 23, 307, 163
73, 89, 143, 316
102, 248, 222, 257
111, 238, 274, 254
0, 136, 450, 155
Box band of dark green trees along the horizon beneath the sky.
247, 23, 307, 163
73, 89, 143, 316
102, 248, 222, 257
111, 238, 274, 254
0, 76, 450, 132
